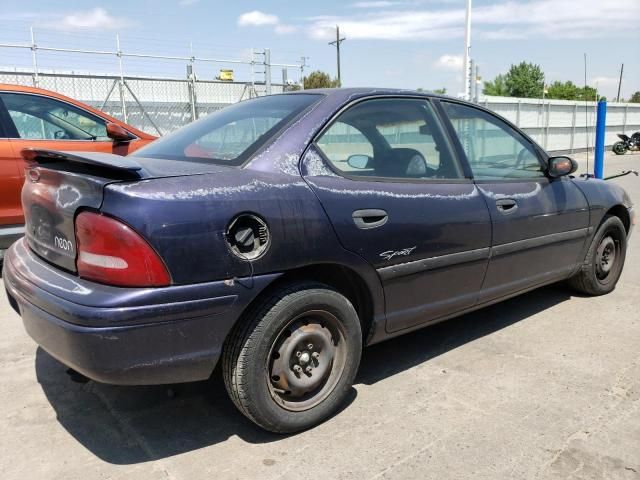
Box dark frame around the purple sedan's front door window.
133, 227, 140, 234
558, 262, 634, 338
433, 98, 551, 184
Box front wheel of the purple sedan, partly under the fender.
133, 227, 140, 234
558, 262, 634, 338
569, 215, 627, 296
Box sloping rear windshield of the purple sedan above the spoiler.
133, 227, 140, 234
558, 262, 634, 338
133, 94, 321, 166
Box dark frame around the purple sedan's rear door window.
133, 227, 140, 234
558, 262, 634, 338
310, 95, 473, 184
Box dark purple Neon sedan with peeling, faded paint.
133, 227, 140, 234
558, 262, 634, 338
4, 89, 635, 432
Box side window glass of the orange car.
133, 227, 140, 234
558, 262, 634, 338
0, 93, 108, 140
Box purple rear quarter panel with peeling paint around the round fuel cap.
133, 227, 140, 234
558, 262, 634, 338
101, 169, 379, 289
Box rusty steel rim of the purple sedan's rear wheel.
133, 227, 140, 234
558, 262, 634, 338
266, 310, 347, 412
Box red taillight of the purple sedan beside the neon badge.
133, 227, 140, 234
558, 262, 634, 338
76, 212, 171, 287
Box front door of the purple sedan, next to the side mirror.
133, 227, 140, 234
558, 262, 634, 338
441, 101, 589, 302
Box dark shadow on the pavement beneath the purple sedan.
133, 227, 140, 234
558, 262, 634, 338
35, 285, 571, 464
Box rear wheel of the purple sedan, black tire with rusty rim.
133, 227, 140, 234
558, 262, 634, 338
222, 283, 362, 433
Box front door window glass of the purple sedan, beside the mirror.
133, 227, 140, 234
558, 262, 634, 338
442, 102, 545, 180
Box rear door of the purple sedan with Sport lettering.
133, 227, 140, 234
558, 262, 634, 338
302, 98, 491, 331
